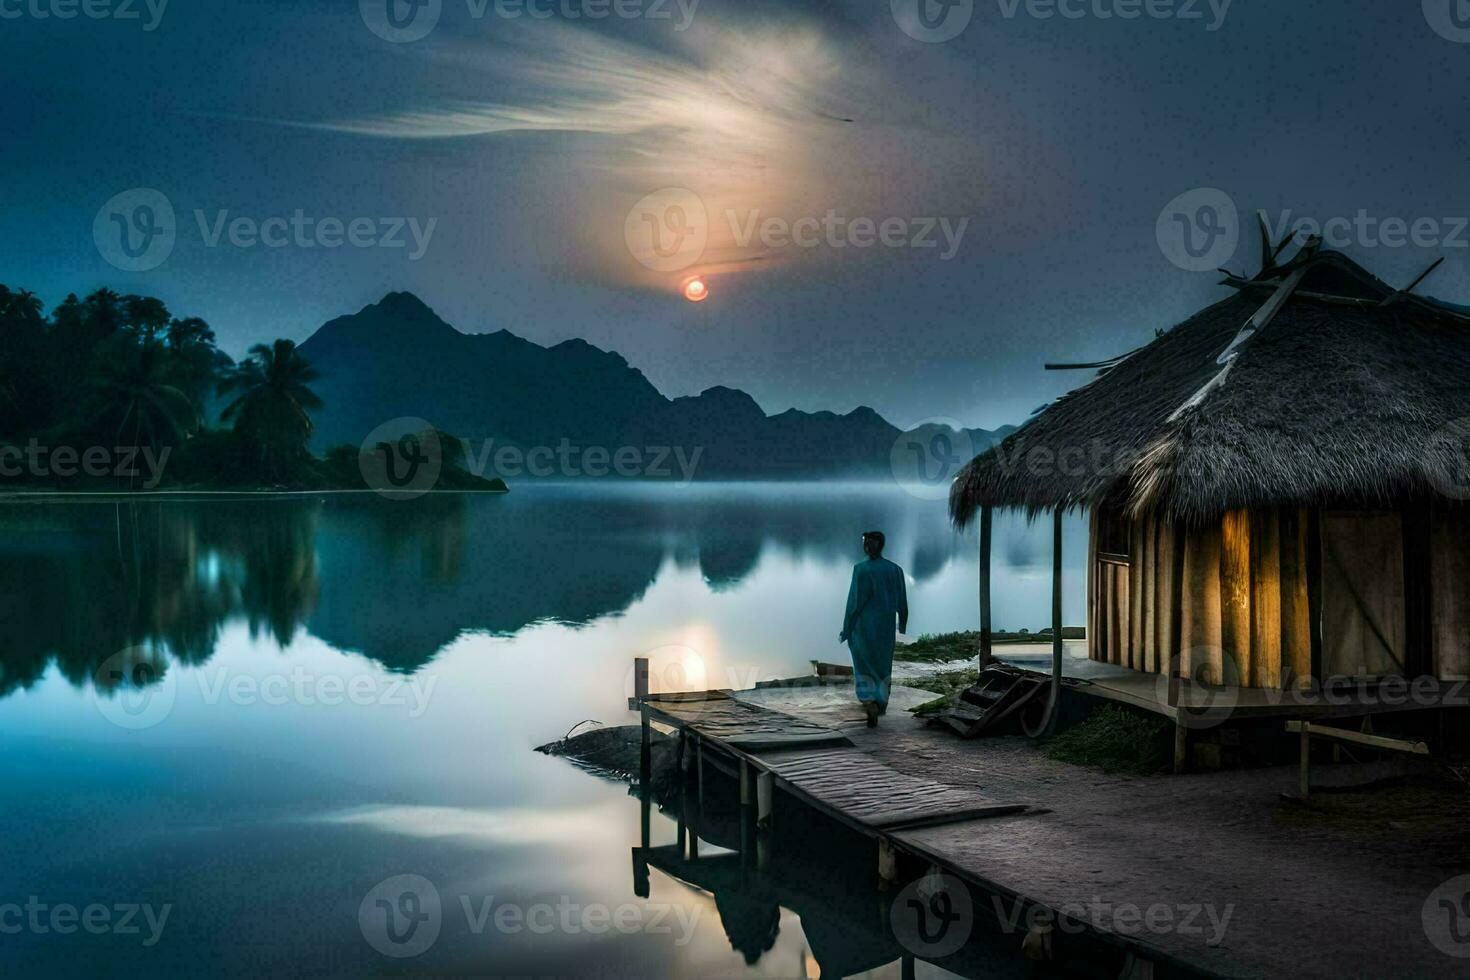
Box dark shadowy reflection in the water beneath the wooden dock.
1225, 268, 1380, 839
632, 770, 1127, 979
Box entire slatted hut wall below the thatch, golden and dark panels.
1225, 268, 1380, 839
1088, 507, 1470, 689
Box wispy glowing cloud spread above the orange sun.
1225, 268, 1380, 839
254, 19, 979, 288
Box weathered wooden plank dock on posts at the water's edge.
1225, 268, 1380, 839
634, 667, 1251, 977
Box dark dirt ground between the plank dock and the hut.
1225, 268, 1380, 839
741, 688, 1470, 977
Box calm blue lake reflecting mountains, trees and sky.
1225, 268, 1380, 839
0, 485, 1085, 977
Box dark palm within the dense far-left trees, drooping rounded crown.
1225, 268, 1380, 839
96, 342, 198, 487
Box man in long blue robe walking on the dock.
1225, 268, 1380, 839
838, 530, 908, 727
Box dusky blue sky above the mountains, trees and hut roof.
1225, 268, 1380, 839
0, 0, 1470, 426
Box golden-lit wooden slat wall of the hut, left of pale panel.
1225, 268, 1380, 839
1088, 508, 1311, 689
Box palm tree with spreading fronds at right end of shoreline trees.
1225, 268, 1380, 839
219, 339, 322, 476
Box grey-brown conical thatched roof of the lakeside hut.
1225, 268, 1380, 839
950, 247, 1470, 526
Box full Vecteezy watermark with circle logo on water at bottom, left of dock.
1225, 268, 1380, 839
357, 874, 704, 959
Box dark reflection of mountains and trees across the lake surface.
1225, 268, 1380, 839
0, 485, 1078, 696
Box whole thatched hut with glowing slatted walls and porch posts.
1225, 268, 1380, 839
950, 241, 1470, 743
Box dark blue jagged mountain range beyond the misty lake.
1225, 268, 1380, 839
300, 292, 1011, 479
